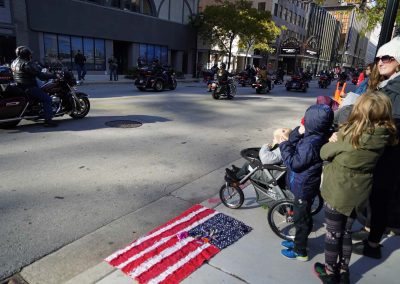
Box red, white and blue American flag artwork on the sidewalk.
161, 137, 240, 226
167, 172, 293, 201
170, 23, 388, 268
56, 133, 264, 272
105, 204, 252, 283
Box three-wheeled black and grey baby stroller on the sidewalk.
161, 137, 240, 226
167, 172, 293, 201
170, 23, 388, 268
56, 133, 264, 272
219, 148, 323, 240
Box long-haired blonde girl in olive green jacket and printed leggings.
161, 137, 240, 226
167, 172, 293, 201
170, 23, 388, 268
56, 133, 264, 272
314, 92, 397, 284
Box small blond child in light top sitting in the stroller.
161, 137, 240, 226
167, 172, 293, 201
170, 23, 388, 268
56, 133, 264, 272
226, 128, 292, 182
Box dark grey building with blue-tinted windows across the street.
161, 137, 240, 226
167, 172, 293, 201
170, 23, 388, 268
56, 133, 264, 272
2, 0, 198, 73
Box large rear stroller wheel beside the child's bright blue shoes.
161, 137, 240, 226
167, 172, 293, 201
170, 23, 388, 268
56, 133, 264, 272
268, 199, 296, 241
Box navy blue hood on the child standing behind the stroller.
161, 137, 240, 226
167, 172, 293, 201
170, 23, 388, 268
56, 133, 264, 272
304, 104, 333, 135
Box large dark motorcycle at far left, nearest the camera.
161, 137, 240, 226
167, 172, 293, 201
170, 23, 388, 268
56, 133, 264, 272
0, 67, 90, 128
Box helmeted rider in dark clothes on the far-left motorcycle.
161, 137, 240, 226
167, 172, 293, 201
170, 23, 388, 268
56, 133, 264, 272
11, 46, 57, 127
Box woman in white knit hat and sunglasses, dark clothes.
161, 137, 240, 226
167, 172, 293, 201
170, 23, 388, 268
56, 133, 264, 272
353, 37, 400, 259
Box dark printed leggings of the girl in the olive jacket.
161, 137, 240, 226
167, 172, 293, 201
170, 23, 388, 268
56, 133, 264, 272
325, 203, 355, 273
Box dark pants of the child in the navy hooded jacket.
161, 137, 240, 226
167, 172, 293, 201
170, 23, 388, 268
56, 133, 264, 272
293, 198, 313, 254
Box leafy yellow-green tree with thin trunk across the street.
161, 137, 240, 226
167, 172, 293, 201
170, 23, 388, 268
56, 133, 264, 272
191, 0, 279, 69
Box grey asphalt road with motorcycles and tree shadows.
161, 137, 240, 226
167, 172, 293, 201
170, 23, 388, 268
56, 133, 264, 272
0, 81, 346, 279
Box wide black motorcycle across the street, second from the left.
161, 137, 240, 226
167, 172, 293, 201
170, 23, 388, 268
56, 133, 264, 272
135, 66, 178, 92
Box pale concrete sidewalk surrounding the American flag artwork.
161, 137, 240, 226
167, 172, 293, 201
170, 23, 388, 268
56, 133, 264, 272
12, 155, 400, 284
